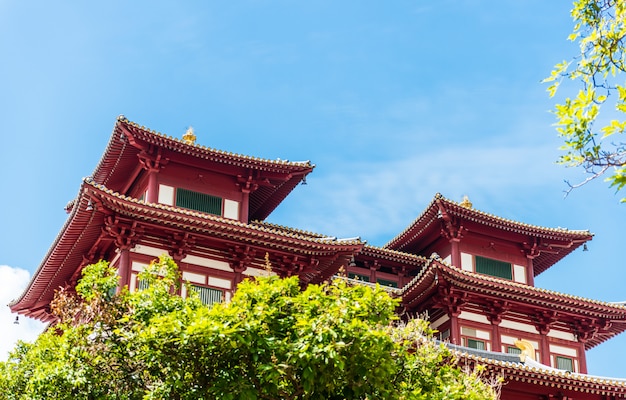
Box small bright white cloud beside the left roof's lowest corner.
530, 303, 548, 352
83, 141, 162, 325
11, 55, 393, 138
0, 265, 45, 361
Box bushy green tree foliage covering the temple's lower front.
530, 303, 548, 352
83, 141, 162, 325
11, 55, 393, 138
0, 257, 497, 399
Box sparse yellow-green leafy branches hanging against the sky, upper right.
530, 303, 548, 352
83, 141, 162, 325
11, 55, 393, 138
545, 0, 626, 201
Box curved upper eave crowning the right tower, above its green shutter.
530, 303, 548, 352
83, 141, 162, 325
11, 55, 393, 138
383, 194, 593, 276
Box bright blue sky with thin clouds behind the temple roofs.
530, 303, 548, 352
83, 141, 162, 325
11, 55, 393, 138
0, 0, 626, 377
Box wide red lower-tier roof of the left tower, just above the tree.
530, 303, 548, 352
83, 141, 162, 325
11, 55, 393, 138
10, 180, 363, 320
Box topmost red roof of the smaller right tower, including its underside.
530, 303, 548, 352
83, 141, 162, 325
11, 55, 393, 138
384, 194, 593, 276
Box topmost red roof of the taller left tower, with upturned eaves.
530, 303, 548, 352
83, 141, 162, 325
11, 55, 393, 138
91, 117, 315, 220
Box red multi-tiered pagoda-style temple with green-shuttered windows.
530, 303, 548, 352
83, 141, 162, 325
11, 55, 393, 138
10, 117, 626, 400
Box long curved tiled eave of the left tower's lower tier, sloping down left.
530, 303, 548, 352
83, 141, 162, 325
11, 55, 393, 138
9, 181, 363, 321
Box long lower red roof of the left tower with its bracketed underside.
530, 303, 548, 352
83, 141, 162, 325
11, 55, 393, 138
11, 183, 363, 320
